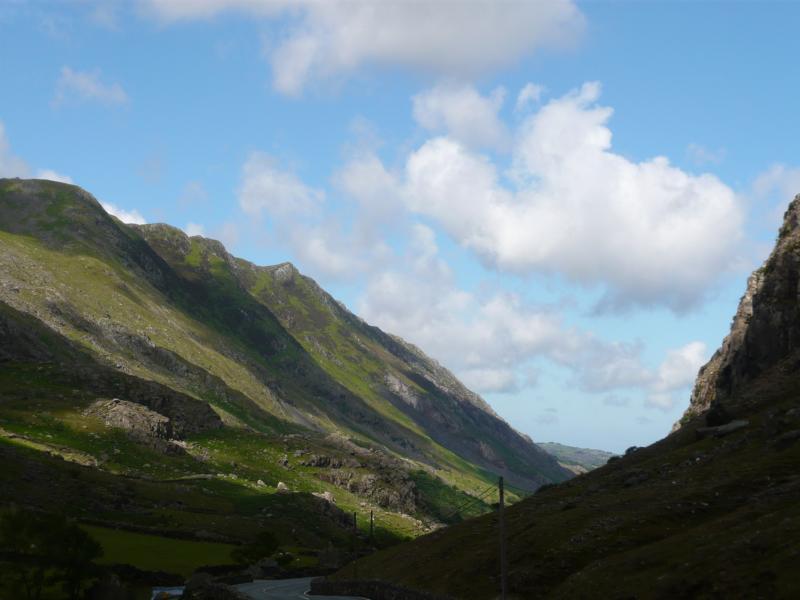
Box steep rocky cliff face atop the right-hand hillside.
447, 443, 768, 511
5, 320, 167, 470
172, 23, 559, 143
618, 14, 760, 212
676, 195, 800, 428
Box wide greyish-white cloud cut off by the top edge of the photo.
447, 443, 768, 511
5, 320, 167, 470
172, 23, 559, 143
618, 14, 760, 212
142, 0, 584, 95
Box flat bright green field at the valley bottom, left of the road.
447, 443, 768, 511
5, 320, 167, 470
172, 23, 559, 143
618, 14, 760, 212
83, 525, 235, 577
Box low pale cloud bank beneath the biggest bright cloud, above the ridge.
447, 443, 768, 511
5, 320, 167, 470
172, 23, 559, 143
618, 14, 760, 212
358, 224, 705, 398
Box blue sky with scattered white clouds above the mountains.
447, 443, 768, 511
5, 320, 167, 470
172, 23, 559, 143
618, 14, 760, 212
0, 0, 800, 452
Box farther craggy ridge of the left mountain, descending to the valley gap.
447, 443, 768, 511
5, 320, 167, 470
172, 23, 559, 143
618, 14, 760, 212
137, 225, 567, 489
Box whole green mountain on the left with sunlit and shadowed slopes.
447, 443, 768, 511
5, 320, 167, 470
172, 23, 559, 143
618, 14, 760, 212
0, 179, 571, 576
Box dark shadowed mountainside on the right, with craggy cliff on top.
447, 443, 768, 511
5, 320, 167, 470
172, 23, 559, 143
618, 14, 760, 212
332, 196, 800, 600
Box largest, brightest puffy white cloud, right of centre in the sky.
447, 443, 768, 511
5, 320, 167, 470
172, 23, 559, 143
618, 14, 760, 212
404, 84, 743, 311
